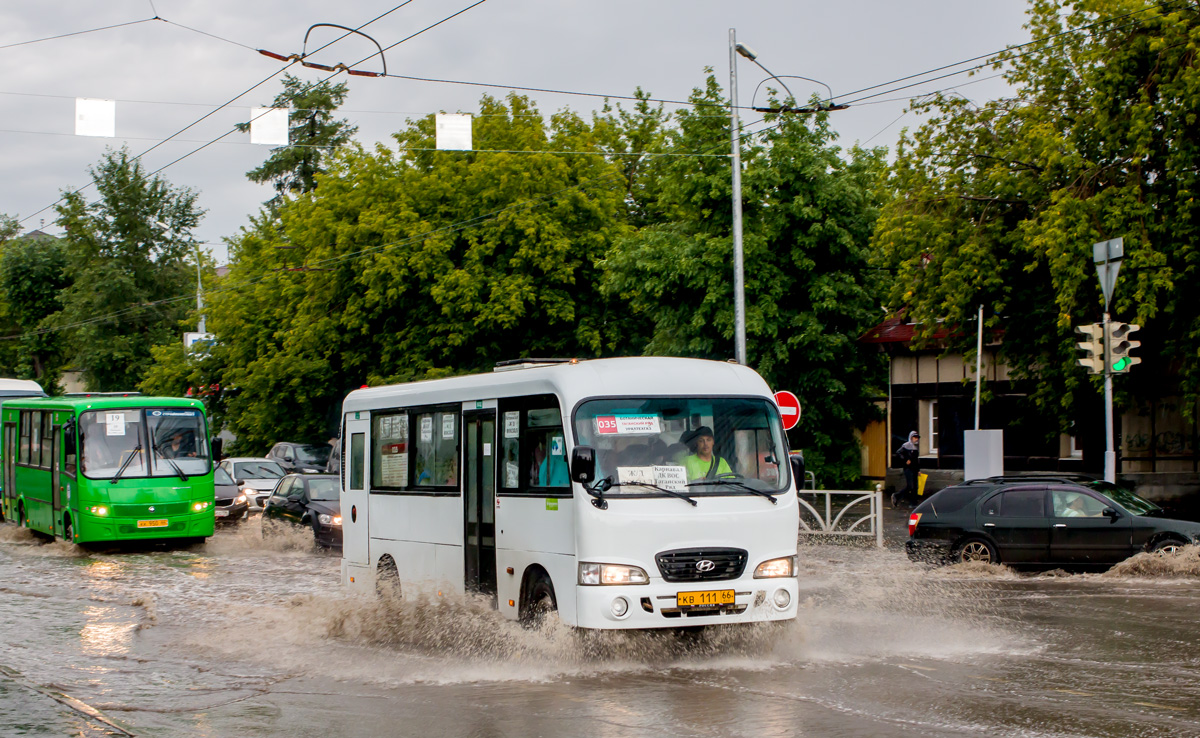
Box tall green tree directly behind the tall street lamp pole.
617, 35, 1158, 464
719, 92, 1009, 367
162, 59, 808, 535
605, 77, 883, 485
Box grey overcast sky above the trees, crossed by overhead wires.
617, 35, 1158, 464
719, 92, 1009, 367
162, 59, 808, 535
0, 0, 1028, 262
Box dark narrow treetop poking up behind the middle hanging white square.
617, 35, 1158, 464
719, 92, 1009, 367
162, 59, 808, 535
236, 74, 358, 208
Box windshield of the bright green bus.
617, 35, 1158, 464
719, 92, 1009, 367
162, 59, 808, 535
79, 408, 210, 479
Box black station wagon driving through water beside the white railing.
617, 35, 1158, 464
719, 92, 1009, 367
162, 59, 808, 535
906, 475, 1200, 568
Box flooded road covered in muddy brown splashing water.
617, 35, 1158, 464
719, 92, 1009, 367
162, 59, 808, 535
0, 521, 1200, 738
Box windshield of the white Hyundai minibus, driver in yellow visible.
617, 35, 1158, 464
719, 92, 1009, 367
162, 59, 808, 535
575, 397, 788, 496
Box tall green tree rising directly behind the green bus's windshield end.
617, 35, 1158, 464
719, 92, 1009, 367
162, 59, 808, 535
53, 149, 203, 391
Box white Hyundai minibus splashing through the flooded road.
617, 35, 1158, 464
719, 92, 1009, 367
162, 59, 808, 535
341, 358, 799, 629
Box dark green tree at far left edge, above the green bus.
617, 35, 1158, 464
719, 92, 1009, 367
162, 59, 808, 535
0, 234, 71, 392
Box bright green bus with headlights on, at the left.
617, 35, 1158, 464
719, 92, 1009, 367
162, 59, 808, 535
0, 395, 215, 544
